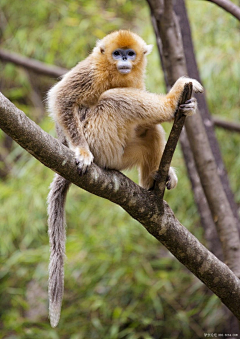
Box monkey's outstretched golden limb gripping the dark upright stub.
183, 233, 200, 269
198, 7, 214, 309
95, 77, 203, 124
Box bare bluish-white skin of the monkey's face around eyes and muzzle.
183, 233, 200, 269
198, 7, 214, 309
112, 48, 136, 74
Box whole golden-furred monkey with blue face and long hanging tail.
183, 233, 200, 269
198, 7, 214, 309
48, 30, 203, 327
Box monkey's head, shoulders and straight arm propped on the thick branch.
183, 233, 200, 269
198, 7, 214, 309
48, 30, 152, 174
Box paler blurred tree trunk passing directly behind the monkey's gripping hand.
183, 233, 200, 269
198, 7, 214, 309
145, 0, 240, 277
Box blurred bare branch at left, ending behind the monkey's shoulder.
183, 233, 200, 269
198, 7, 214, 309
0, 49, 68, 78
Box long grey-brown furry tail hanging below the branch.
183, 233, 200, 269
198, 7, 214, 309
47, 174, 71, 327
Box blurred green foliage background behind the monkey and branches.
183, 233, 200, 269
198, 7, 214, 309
0, 0, 240, 339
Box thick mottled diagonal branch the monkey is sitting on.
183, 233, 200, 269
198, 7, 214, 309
0, 94, 240, 319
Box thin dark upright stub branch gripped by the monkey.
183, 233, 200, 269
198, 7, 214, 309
154, 83, 192, 199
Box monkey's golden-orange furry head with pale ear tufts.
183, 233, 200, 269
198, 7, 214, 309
93, 30, 153, 86
